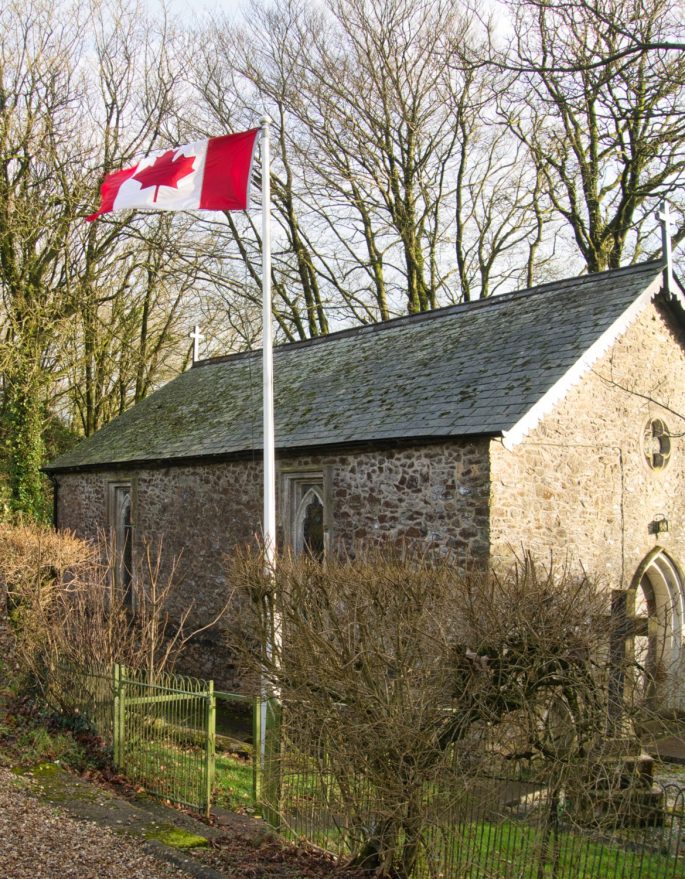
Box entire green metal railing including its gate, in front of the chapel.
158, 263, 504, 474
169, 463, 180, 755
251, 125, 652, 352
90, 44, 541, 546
62, 666, 685, 879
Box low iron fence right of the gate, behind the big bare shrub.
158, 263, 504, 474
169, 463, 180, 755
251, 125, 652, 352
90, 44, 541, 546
260, 713, 685, 879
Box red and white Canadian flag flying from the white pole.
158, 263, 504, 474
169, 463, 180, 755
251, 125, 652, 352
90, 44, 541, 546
86, 128, 261, 222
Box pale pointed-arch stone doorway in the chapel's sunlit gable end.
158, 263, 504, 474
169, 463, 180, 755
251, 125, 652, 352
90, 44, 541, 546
631, 548, 685, 710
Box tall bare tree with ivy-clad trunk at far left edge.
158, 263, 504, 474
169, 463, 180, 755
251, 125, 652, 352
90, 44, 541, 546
0, 0, 93, 515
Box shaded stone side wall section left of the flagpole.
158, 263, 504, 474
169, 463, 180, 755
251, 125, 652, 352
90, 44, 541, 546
52, 462, 261, 689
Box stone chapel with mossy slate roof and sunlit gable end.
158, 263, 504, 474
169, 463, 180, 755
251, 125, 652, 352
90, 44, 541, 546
46, 262, 685, 710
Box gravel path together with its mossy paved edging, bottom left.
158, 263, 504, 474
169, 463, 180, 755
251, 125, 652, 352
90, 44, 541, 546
0, 618, 230, 879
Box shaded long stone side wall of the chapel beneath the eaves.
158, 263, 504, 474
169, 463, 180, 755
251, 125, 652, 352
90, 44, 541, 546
57, 440, 489, 689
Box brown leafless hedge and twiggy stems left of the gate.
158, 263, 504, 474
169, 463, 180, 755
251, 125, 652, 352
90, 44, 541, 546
0, 526, 219, 712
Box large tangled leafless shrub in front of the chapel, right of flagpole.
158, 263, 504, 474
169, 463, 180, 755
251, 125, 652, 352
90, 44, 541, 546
233, 554, 609, 877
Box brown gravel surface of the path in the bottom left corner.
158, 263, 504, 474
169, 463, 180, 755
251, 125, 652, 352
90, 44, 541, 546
0, 768, 188, 879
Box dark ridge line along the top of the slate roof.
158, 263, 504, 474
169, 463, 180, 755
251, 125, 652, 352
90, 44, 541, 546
192, 259, 662, 369
